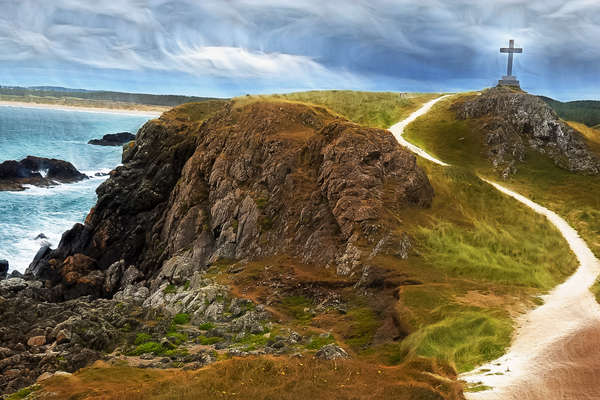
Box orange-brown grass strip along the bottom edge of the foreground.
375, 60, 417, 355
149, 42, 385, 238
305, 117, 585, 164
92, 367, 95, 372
35, 356, 460, 400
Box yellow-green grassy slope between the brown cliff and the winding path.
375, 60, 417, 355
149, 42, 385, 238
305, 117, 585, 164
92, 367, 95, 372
375, 160, 577, 371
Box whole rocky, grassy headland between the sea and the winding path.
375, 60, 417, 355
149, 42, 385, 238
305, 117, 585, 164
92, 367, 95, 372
0, 92, 576, 399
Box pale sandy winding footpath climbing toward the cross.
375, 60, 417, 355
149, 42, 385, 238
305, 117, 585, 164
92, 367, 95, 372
390, 96, 600, 400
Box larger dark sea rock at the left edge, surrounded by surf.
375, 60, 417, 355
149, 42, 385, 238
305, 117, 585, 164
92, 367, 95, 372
0, 156, 88, 191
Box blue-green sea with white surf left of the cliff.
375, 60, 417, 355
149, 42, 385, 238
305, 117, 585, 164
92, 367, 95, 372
0, 107, 151, 272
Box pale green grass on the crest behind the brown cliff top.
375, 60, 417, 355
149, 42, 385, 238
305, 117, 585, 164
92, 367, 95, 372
234, 90, 439, 129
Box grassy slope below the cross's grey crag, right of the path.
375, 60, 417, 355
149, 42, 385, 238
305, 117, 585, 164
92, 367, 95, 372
406, 95, 600, 255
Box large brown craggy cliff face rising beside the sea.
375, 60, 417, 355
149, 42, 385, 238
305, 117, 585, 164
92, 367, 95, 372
29, 103, 433, 298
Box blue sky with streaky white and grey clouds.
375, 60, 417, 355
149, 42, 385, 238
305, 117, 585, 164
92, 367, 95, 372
0, 0, 600, 100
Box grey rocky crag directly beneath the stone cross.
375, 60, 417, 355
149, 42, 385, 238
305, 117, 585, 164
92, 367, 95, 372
455, 88, 600, 177
